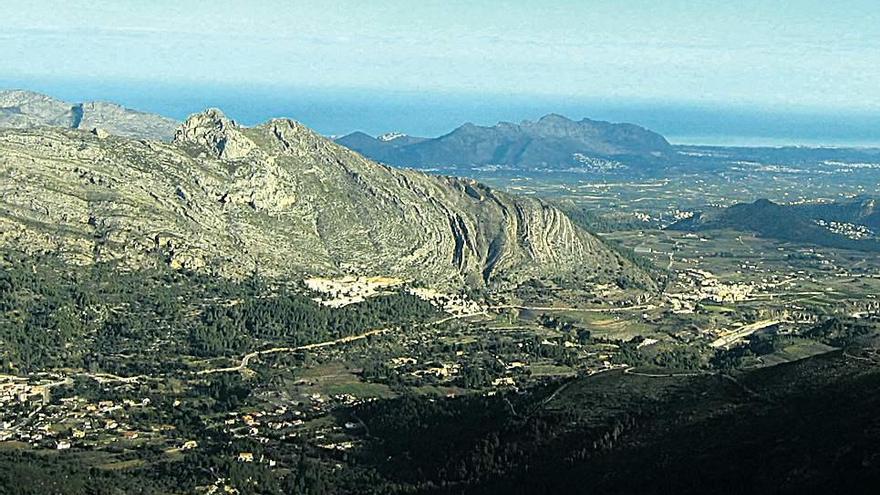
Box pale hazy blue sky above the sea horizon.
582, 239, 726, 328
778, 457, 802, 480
0, 0, 880, 111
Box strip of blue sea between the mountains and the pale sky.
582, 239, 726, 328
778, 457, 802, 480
0, 77, 880, 147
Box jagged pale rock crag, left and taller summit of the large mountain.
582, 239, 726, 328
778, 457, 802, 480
172, 108, 257, 160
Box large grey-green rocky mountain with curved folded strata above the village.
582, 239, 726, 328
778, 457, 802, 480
0, 110, 648, 286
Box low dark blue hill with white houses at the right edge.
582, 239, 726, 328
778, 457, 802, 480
668, 197, 880, 251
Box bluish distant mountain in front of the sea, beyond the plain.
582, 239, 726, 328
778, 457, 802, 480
336, 114, 672, 170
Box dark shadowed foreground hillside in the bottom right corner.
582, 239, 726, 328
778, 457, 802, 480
396, 353, 880, 495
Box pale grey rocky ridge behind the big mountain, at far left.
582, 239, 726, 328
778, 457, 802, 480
0, 90, 178, 141
